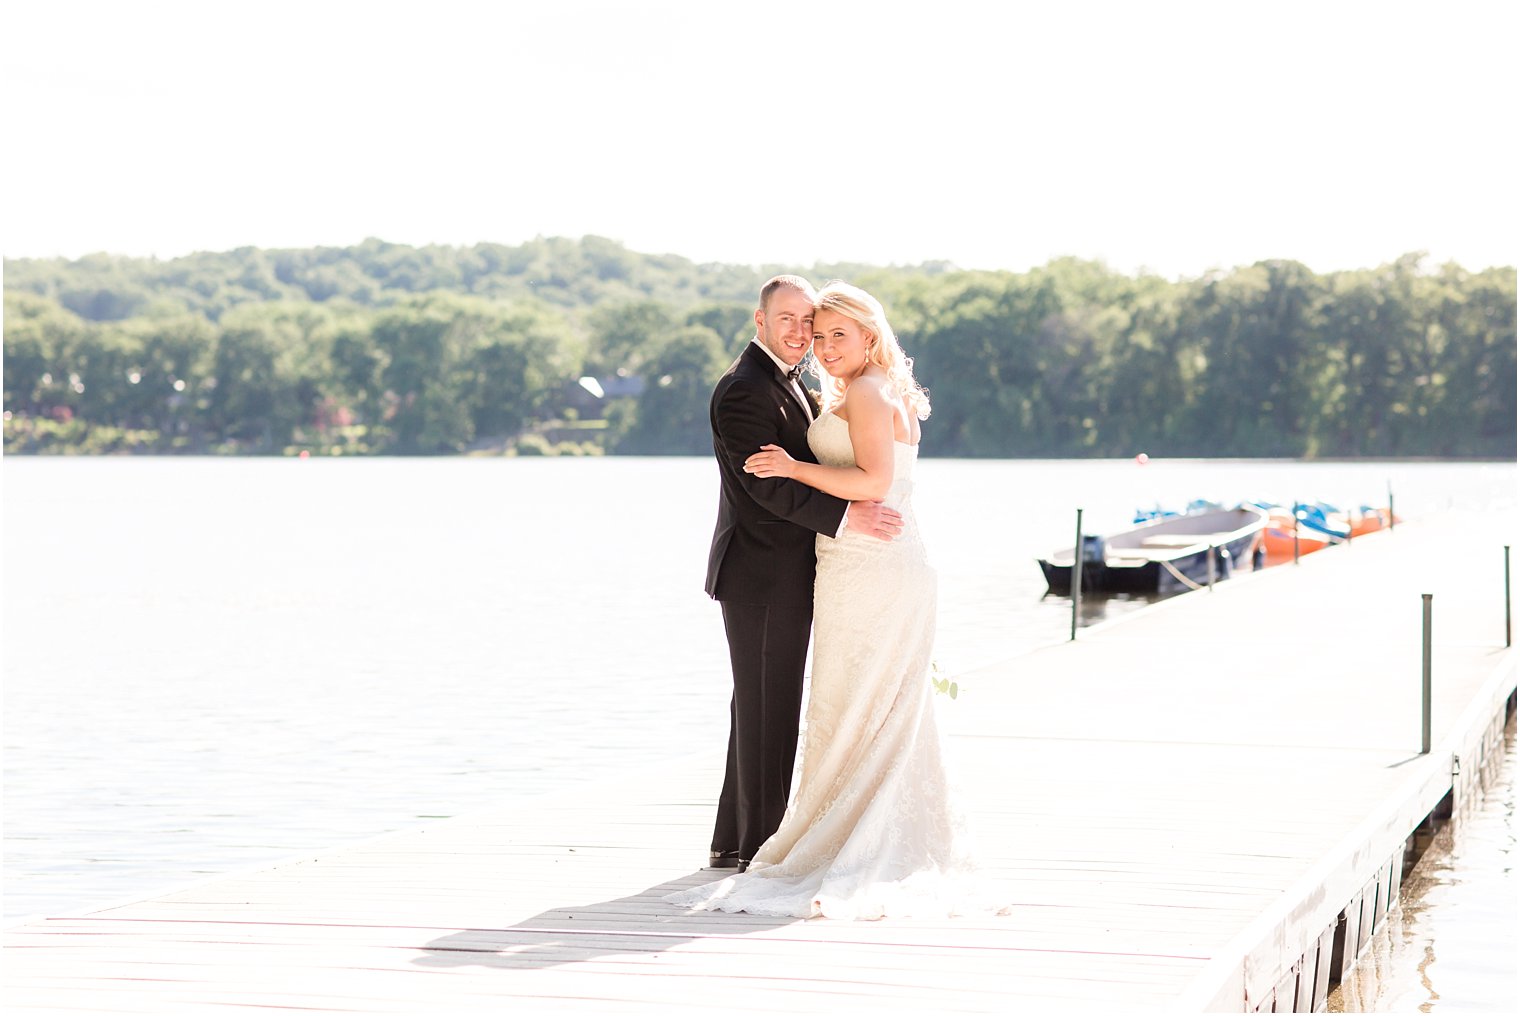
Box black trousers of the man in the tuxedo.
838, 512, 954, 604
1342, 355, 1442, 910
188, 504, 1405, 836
713, 601, 813, 861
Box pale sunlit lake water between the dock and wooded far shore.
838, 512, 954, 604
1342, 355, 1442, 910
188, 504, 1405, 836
0, 456, 1515, 1003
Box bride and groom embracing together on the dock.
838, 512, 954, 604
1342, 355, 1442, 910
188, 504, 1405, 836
666, 275, 1006, 919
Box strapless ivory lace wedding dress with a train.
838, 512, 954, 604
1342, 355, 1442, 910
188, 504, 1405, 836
664, 414, 1005, 919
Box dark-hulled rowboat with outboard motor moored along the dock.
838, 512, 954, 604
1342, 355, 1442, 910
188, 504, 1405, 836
1040, 505, 1268, 595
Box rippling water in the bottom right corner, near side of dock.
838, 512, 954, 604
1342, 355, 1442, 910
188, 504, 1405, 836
1328, 713, 1520, 1013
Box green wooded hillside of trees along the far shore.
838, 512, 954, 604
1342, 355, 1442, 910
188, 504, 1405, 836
5, 237, 1515, 458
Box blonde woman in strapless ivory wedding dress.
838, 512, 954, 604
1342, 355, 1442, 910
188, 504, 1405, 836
664, 281, 1005, 919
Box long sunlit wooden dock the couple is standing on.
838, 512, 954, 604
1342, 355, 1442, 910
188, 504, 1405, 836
5, 513, 1515, 1014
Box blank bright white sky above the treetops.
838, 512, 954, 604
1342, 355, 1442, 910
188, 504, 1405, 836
0, 0, 1520, 277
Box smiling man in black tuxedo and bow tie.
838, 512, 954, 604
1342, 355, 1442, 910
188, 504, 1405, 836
707, 275, 901, 872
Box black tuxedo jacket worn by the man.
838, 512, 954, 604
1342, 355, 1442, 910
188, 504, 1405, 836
707, 342, 848, 604
